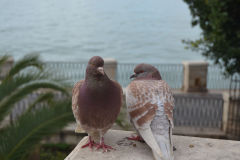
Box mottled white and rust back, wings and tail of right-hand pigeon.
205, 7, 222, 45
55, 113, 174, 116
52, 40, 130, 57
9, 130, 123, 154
126, 80, 174, 159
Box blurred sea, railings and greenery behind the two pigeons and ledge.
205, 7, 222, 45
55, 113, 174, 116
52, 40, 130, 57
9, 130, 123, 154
0, 0, 240, 160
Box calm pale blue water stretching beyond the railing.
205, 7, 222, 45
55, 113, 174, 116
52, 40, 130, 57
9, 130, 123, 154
0, 0, 203, 63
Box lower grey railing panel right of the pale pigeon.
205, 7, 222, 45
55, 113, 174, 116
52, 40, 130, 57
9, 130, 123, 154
174, 94, 224, 129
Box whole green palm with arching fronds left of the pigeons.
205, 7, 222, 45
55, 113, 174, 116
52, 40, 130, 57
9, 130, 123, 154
0, 55, 74, 160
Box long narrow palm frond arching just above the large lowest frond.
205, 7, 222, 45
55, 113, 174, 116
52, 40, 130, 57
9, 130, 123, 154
0, 80, 68, 123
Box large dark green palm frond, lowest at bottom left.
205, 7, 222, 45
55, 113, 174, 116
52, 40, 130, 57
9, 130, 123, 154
0, 99, 74, 160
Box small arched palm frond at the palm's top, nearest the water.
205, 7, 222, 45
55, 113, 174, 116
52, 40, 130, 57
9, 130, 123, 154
6, 54, 44, 79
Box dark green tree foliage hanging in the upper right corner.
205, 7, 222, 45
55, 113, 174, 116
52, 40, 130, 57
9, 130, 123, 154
184, 0, 240, 75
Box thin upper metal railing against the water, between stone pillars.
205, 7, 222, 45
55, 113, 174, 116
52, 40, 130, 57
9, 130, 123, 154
41, 62, 230, 89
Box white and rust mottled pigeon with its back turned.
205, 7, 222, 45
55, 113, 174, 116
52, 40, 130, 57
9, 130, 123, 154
126, 63, 174, 160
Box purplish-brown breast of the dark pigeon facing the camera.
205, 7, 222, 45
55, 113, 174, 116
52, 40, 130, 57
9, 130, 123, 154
78, 81, 122, 129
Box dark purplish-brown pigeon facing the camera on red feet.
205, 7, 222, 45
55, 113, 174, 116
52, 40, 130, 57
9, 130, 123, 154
72, 56, 123, 152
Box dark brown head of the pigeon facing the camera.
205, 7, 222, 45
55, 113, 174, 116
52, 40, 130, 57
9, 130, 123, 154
86, 56, 107, 80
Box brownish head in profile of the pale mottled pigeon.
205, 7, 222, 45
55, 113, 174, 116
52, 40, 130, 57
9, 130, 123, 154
130, 63, 162, 80
